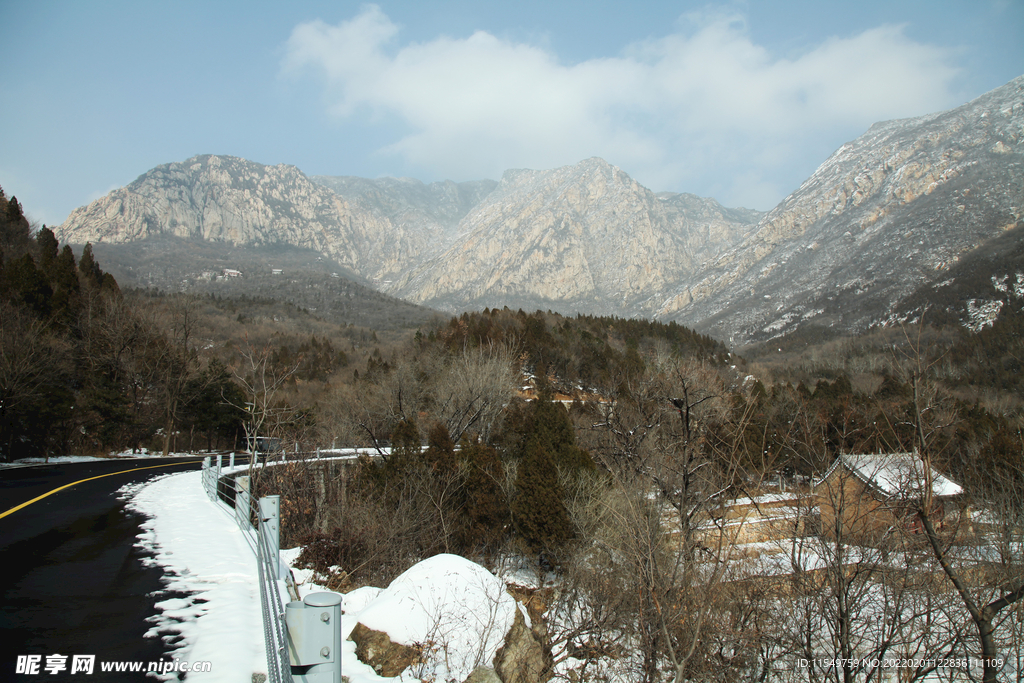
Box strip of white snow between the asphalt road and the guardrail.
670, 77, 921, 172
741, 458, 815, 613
119, 471, 266, 683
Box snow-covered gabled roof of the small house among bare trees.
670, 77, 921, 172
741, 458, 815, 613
814, 453, 964, 498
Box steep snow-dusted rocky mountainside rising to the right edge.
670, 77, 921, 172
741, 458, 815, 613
671, 77, 1024, 342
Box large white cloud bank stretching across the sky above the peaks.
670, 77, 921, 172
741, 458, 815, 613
283, 5, 956, 208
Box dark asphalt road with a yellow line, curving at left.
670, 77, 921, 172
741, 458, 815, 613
0, 458, 200, 681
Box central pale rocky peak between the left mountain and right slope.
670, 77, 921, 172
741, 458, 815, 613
391, 159, 761, 315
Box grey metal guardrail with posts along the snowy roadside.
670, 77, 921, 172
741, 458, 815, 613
203, 454, 350, 683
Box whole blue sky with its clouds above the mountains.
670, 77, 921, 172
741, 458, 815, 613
0, 0, 1024, 225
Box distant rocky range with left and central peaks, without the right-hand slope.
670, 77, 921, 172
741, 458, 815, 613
57, 156, 762, 315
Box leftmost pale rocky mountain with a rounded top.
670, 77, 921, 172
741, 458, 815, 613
57, 155, 444, 280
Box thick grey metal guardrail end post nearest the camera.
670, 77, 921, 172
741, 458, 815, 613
285, 592, 341, 683
